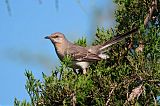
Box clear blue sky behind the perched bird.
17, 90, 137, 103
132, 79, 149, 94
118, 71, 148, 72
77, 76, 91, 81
0, 0, 114, 105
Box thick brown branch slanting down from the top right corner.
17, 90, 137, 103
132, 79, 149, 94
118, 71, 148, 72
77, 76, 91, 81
144, 0, 157, 27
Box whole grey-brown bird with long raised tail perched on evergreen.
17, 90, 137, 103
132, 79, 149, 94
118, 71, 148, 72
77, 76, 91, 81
45, 28, 138, 74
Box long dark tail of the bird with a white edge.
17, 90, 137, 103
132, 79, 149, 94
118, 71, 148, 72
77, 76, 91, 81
99, 28, 138, 51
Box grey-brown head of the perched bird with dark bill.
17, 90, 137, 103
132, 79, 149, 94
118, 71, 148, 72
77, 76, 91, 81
45, 32, 65, 43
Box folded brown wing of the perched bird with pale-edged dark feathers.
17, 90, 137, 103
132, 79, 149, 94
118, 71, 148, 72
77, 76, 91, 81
65, 45, 101, 62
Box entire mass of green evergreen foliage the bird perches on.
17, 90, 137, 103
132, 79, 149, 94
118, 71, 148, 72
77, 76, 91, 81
14, 0, 160, 106
